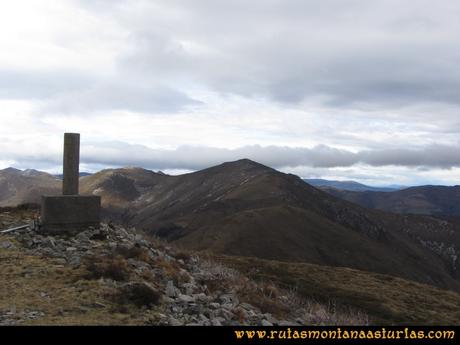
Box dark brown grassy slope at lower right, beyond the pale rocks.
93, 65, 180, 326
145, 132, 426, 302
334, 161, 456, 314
215, 256, 460, 325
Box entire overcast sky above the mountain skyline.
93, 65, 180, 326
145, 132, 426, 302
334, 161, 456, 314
0, 0, 460, 185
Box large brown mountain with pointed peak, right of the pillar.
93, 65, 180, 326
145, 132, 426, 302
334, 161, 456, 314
0, 163, 460, 291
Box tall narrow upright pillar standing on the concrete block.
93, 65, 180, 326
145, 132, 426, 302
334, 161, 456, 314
62, 133, 80, 195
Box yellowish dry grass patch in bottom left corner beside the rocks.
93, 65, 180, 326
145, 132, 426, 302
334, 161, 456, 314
0, 236, 150, 325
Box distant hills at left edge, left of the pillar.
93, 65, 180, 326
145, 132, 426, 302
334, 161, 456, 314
0, 168, 62, 207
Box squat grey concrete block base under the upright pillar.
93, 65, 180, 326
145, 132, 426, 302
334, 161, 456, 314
40, 195, 101, 233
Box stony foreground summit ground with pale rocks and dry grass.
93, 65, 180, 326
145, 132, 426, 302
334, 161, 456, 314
0, 209, 369, 326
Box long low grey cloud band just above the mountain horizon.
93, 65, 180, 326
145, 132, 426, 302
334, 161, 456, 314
4, 142, 460, 170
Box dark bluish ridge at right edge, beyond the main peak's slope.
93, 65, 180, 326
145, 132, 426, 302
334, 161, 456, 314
326, 186, 460, 217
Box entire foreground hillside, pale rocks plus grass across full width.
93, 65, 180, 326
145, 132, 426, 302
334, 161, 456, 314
0, 208, 460, 325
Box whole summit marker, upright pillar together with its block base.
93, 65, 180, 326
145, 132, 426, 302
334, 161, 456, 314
40, 133, 101, 233
